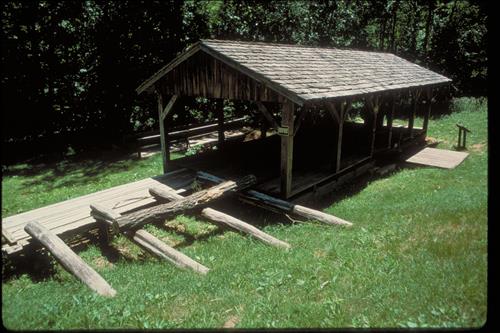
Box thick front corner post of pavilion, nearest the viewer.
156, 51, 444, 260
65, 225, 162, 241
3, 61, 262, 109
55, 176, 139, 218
280, 101, 295, 198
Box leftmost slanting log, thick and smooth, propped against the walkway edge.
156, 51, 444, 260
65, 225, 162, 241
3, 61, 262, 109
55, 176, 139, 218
24, 221, 116, 297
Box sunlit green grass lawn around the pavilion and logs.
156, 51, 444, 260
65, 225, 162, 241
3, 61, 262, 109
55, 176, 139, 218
2, 98, 488, 330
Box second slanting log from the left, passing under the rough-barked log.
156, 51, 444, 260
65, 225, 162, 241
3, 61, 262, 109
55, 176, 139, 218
90, 204, 209, 274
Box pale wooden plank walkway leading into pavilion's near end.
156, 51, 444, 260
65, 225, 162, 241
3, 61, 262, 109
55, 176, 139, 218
2, 169, 195, 255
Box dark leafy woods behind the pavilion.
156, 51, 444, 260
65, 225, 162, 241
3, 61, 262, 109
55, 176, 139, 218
1, 0, 488, 163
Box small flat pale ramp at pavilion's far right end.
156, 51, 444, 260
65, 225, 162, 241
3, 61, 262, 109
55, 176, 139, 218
406, 148, 469, 169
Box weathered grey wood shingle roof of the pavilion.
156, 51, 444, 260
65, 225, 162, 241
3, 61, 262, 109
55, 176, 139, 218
137, 40, 451, 104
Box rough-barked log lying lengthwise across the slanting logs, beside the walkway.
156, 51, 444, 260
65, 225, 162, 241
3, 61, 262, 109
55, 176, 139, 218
114, 175, 256, 232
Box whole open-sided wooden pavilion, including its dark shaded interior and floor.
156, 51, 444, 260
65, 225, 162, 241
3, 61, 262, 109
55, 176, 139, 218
137, 40, 451, 198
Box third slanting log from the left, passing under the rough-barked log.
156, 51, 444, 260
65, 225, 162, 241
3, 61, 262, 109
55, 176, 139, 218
149, 188, 290, 249
